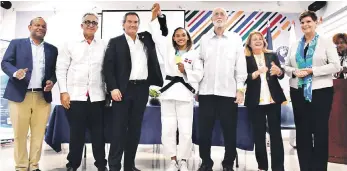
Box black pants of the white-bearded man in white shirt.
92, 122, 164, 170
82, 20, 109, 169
198, 95, 238, 168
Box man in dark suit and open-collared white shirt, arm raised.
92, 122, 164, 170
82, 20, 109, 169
103, 9, 168, 171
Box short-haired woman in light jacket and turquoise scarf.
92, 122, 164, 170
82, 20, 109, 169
284, 11, 341, 171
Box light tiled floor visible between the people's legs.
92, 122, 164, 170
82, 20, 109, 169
0, 141, 347, 171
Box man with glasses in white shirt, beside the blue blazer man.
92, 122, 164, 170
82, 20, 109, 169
56, 13, 107, 171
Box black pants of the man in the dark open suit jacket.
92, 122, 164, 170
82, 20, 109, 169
108, 83, 149, 171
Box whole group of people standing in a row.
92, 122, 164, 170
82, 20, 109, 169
1, 3, 346, 171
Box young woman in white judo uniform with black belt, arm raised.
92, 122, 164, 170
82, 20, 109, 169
149, 4, 203, 171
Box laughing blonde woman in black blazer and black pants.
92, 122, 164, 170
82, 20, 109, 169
245, 31, 286, 171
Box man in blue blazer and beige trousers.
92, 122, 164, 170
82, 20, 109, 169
1, 17, 58, 171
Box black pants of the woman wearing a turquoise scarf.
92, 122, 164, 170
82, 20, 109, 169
290, 87, 334, 171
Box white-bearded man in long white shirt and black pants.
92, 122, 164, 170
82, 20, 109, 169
198, 8, 247, 171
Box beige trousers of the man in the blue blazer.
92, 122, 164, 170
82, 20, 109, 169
9, 92, 51, 171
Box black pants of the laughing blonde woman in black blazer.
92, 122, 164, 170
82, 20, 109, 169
247, 104, 284, 171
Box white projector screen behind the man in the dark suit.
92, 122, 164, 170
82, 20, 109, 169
101, 10, 185, 64
